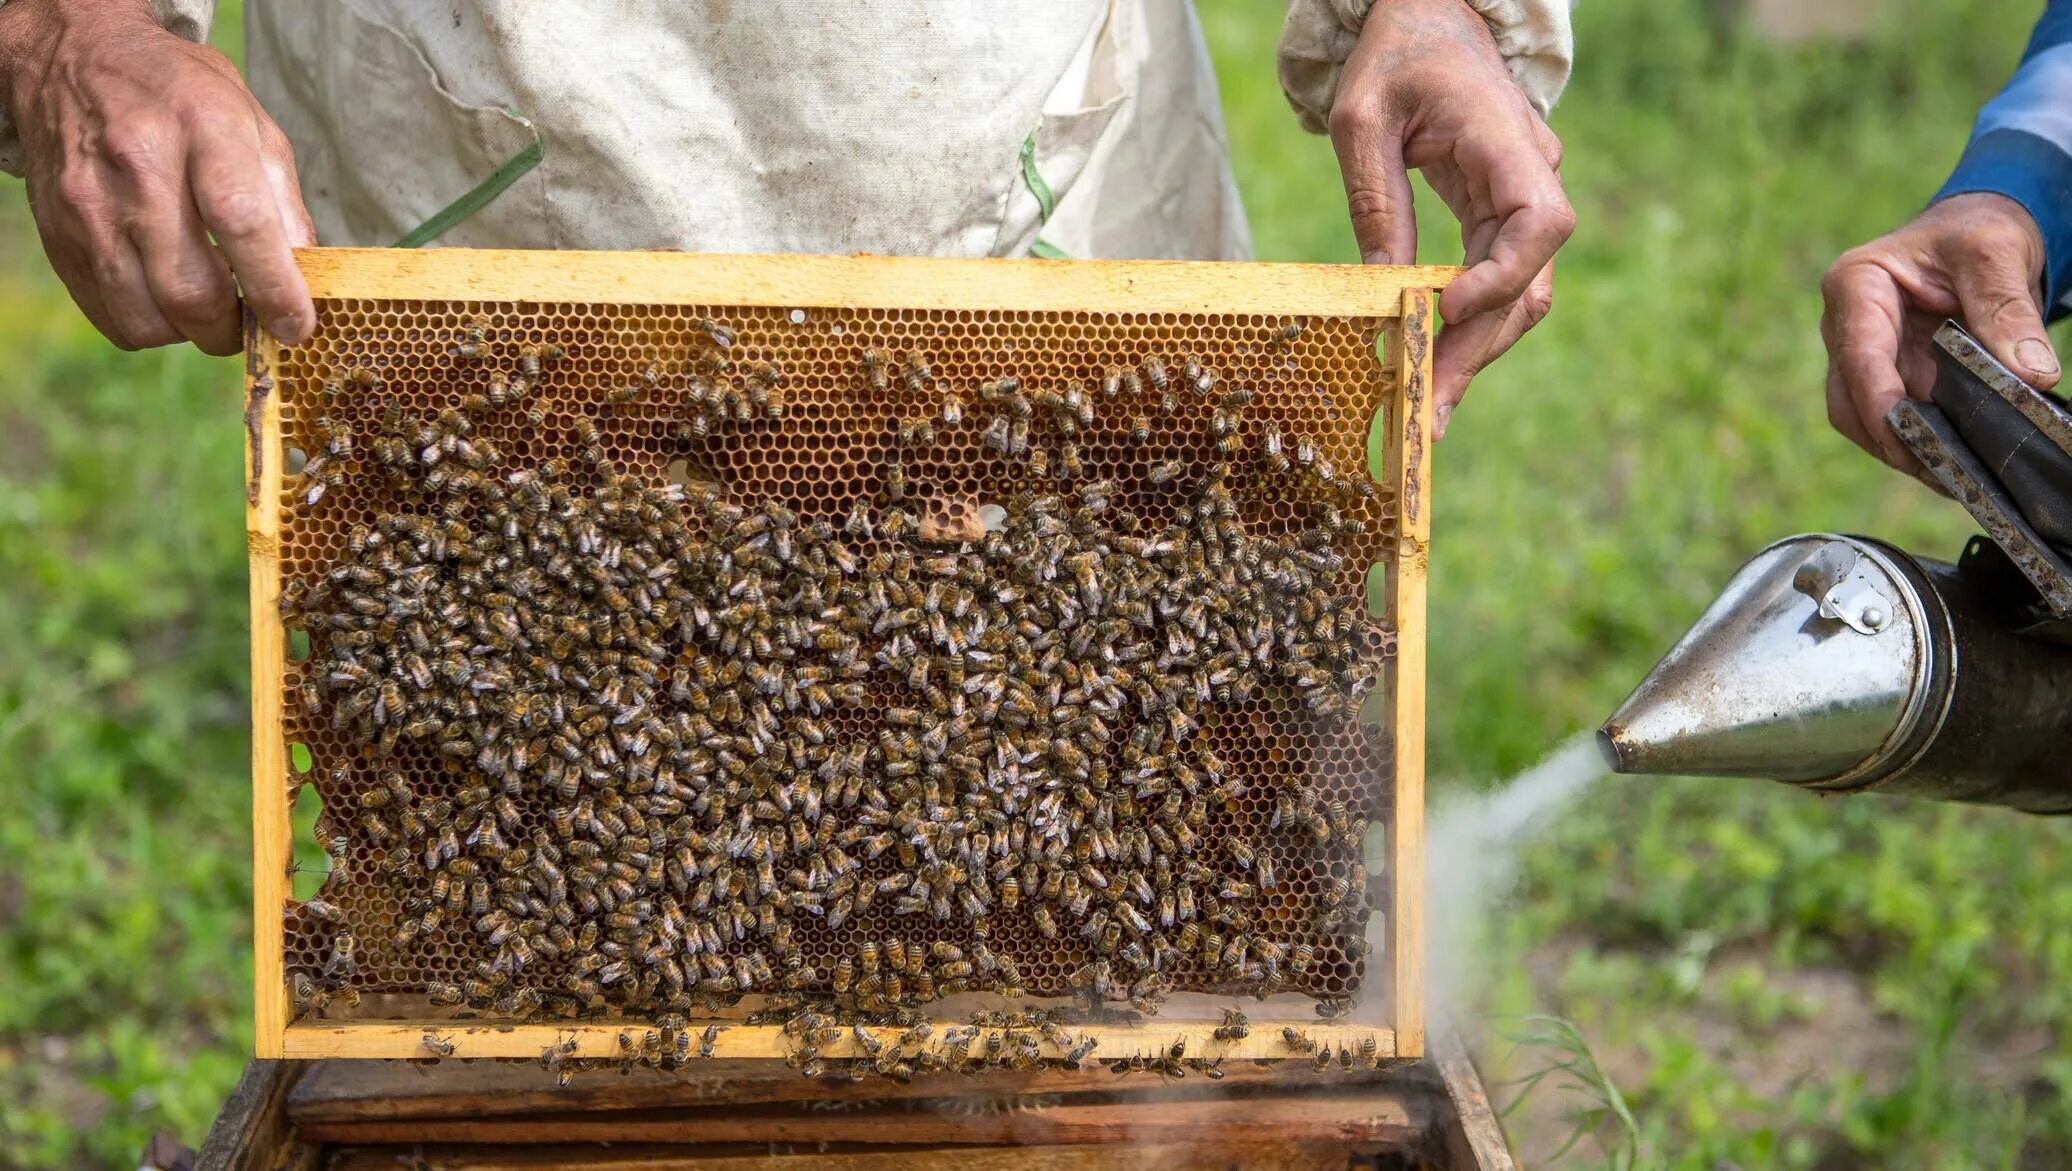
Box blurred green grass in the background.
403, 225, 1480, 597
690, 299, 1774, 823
0, 0, 2072, 1171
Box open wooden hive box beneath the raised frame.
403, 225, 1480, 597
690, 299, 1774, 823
195, 1034, 1515, 1171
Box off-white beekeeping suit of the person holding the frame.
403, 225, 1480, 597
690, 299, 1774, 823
0, 0, 1569, 259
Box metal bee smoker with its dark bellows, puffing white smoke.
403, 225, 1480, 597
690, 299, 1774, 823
1598, 323, 2072, 812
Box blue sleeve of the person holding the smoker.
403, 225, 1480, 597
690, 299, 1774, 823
1935, 0, 2072, 317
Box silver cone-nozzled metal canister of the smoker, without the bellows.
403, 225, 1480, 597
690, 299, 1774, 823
1598, 533, 2072, 812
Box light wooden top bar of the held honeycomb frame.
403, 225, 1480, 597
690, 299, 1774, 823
296, 249, 1461, 317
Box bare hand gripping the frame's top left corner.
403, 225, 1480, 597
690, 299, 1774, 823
0, 0, 317, 354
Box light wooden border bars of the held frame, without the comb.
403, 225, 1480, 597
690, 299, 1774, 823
244, 249, 1459, 1059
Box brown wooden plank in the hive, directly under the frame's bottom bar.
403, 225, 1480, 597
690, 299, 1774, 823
288, 1057, 1430, 1123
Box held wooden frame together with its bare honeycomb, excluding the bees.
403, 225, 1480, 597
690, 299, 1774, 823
244, 249, 1452, 1059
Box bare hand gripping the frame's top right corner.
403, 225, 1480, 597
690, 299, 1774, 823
1330, 0, 1575, 433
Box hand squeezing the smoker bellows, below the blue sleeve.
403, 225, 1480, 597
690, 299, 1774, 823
1819, 193, 2057, 473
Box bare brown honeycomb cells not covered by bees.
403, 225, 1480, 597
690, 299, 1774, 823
254, 298, 1394, 1016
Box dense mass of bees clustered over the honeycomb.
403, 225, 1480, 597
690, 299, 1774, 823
282, 308, 1392, 1078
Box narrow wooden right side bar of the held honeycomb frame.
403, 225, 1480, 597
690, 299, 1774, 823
1388, 288, 1438, 1057
